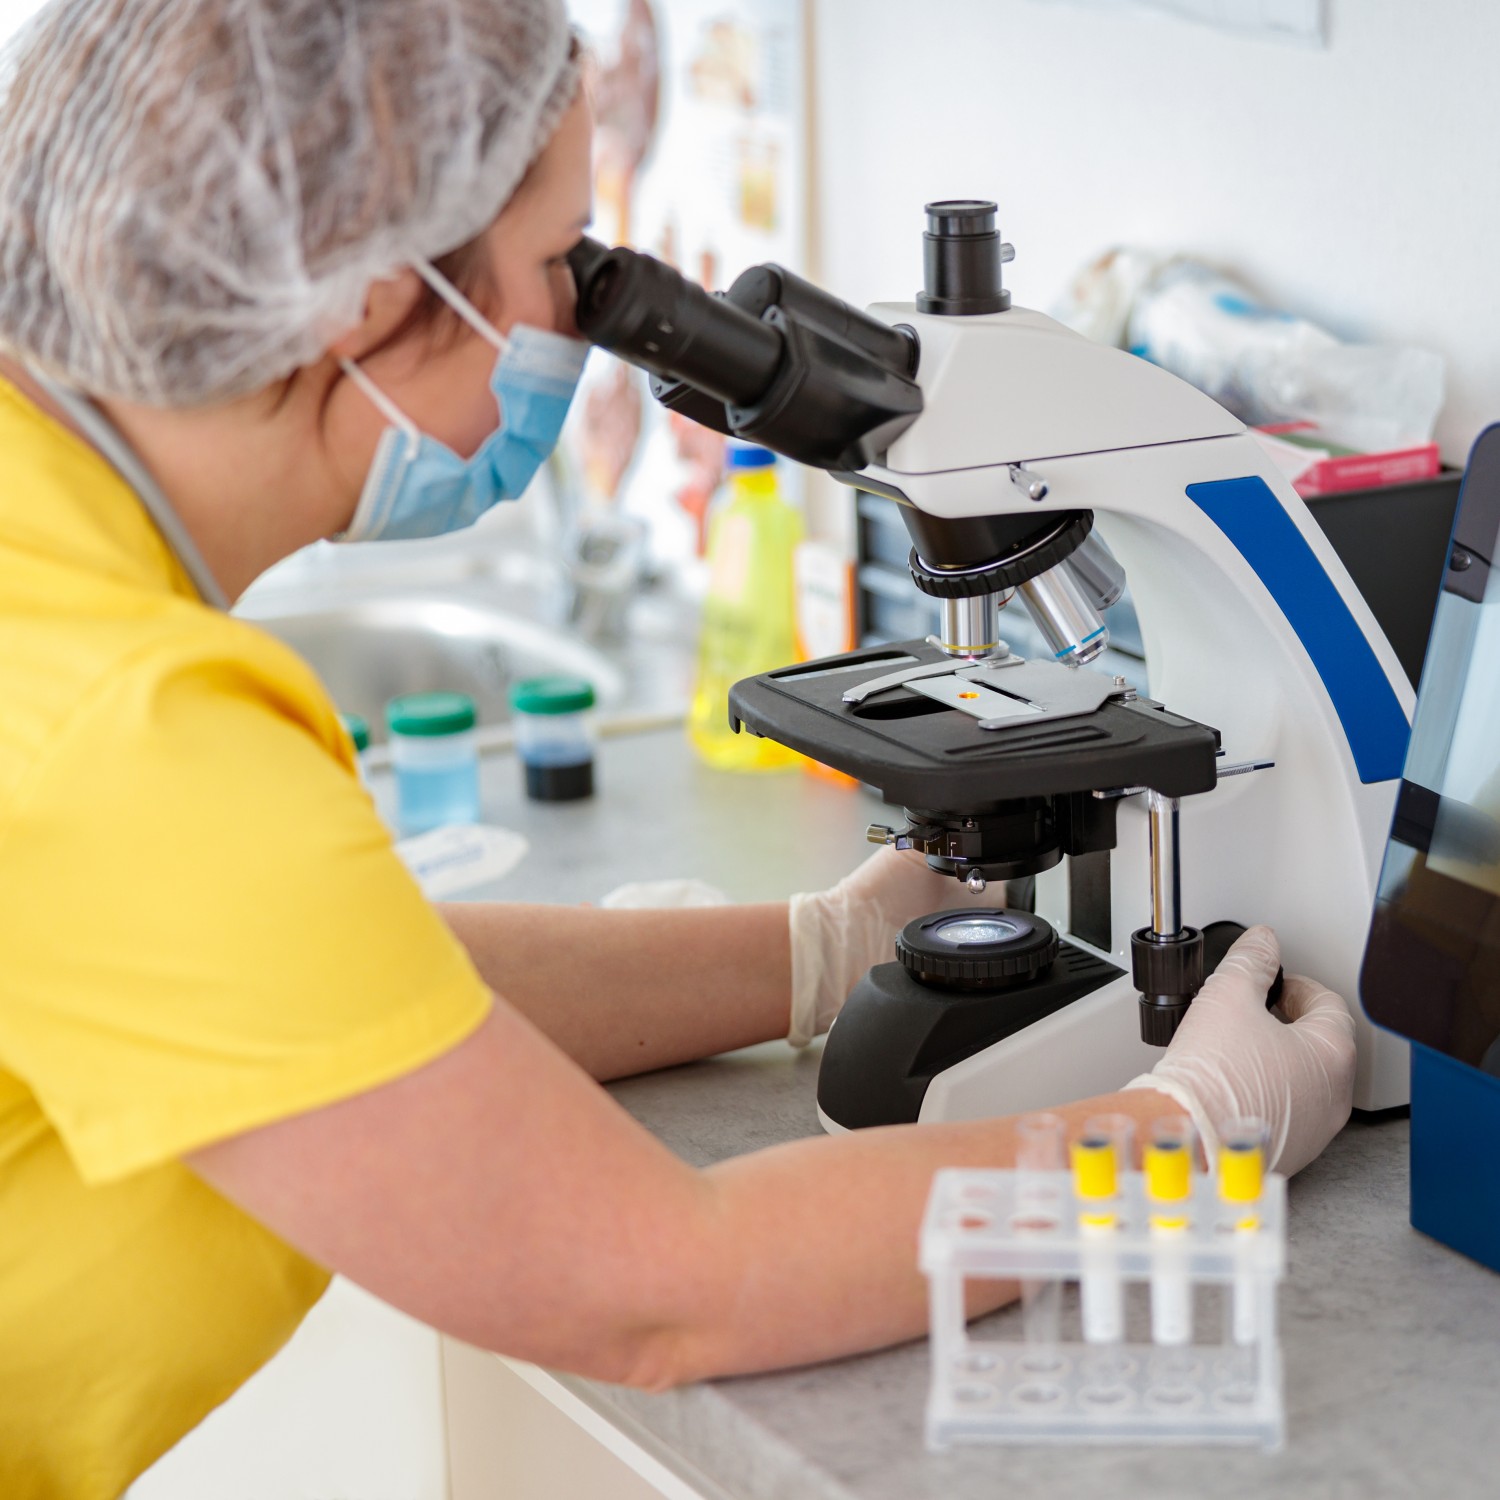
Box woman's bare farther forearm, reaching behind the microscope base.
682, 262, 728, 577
440, 902, 792, 1080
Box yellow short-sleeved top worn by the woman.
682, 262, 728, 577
0, 383, 489, 1500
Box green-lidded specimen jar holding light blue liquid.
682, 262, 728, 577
386, 693, 480, 839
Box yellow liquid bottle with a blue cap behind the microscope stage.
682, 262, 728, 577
687, 444, 803, 771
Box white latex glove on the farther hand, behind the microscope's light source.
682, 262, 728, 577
786, 849, 1005, 1047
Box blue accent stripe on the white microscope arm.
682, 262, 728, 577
1188, 476, 1412, 782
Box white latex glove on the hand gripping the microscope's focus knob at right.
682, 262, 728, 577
1125, 927, 1355, 1176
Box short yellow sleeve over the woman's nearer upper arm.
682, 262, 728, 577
0, 623, 491, 1182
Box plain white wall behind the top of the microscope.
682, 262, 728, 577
816, 0, 1500, 464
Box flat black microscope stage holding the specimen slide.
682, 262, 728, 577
729, 641, 1220, 810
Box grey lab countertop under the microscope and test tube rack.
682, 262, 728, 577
417, 732, 1500, 1500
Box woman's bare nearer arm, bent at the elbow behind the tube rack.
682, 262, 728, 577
189, 984, 1178, 1389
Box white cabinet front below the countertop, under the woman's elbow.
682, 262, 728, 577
128, 1278, 729, 1500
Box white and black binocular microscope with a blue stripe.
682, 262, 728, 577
570, 201, 1413, 1130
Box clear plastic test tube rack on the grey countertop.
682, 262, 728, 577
921, 1169, 1286, 1451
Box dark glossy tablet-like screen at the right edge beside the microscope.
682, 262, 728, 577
1361, 426, 1500, 1077
